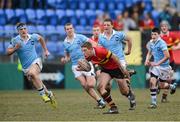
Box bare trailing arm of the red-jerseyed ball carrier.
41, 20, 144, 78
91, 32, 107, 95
111, 53, 130, 78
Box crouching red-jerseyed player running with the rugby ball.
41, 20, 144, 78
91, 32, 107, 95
81, 42, 136, 114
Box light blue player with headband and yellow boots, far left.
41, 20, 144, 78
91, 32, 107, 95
7, 23, 56, 107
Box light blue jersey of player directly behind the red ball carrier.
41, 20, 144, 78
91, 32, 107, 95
98, 30, 126, 60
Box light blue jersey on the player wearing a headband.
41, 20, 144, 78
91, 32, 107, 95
8, 34, 39, 69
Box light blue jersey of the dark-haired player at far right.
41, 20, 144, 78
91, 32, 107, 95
147, 38, 169, 67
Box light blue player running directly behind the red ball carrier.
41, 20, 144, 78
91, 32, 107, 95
98, 19, 136, 110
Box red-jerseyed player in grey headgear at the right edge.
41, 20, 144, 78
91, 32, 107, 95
160, 21, 180, 102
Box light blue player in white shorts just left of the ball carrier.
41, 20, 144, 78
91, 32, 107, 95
61, 23, 105, 108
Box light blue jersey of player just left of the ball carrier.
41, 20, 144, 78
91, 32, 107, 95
63, 34, 88, 65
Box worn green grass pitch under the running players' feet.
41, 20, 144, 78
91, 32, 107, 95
0, 89, 180, 121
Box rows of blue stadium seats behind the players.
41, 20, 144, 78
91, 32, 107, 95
0, 0, 178, 56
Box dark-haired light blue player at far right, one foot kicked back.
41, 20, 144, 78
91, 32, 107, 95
145, 28, 176, 109
